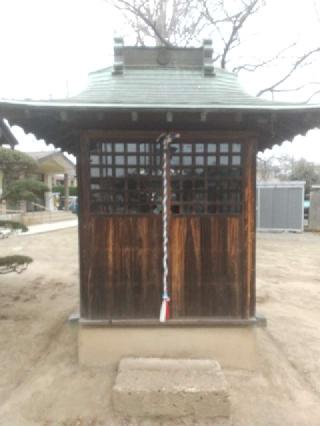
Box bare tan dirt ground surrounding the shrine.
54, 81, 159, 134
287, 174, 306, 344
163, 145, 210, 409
0, 228, 320, 426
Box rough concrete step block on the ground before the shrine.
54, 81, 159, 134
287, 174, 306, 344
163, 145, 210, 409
112, 358, 230, 418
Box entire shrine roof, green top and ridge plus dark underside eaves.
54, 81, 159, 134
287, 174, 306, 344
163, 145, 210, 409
0, 39, 320, 152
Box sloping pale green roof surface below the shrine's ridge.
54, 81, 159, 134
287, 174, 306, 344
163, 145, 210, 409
65, 67, 304, 109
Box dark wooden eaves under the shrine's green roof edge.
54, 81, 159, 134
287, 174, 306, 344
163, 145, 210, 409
0, 104, 320, 154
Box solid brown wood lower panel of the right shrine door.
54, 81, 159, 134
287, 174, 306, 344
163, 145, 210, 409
170, 216, 244, 318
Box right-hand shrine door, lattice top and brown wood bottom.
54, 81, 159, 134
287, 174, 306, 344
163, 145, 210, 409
170, 138, 244, 318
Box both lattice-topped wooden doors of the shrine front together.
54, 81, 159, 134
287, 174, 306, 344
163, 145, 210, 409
80, 132, 254, 320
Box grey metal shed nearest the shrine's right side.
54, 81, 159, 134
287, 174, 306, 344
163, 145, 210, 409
257, 181, 305, 232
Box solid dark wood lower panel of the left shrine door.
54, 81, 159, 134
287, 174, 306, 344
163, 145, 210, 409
82, 216, 162, 319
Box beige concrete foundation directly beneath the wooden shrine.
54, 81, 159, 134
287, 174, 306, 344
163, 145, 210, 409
78, 325, 258, 370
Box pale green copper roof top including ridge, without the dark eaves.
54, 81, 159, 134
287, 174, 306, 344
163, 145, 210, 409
0, 41, 313, 112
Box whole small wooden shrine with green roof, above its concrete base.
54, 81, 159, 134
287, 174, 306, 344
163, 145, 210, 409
0, 39, 320, 325
